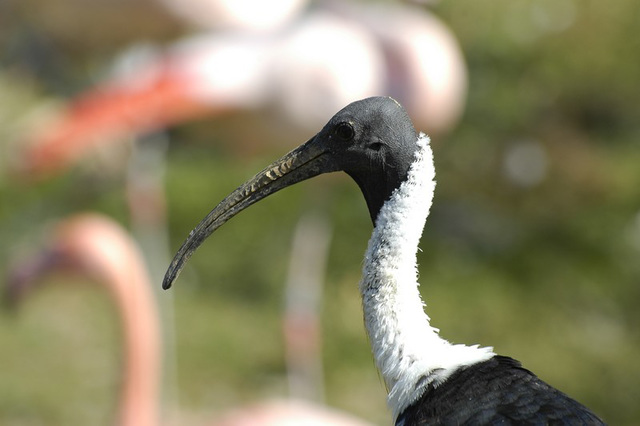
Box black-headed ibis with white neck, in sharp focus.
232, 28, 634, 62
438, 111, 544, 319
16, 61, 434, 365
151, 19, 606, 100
163, 97, 602, 426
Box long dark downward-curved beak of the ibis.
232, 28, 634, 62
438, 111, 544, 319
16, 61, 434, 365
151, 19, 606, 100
162, 135, 339, 290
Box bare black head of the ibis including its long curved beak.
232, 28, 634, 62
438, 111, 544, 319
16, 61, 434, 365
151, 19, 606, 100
162, 97, 418, 289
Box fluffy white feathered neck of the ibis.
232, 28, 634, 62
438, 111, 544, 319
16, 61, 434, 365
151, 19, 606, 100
360, 133, 494, 419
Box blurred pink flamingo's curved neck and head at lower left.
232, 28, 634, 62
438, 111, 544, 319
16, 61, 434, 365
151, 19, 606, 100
7, 213, 161, 426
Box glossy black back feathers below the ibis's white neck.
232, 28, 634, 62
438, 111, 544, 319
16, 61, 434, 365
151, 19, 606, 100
396, 356, 605, 426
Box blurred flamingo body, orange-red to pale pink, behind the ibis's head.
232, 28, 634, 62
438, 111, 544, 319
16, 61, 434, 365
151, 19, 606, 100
13, 2, 466, 175
